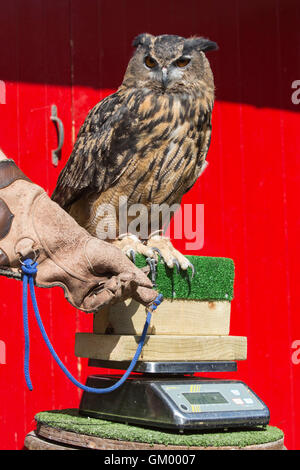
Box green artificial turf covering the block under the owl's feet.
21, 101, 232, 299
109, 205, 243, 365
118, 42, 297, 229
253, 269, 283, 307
136, 255, 234, 301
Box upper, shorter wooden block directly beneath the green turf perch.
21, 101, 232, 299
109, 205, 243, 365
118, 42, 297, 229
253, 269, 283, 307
93, 300, 231, 336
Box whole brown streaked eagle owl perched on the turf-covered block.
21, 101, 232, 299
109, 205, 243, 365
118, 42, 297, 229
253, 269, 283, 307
52, 33, 217, 280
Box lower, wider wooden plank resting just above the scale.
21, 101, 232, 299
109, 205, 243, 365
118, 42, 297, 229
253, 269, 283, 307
75, 333, 247, 361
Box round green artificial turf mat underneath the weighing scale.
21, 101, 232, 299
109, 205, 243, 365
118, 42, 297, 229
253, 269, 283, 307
35, 409, 283, 448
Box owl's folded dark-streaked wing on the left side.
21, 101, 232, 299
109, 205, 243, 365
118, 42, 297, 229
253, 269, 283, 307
51, 93, 134, 209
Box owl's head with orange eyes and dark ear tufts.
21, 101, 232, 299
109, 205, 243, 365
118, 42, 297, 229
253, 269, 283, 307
123, 33, 218, 93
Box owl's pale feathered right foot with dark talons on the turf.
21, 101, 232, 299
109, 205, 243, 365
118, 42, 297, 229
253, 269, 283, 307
147, 235, 195, 278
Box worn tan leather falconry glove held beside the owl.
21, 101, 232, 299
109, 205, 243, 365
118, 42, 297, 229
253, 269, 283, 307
0, 151, 157, 312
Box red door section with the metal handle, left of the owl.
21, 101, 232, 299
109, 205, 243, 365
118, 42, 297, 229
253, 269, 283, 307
0, 1, 91, 449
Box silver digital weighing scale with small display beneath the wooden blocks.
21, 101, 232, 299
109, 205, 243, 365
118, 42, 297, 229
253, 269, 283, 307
79, 360, 270, 432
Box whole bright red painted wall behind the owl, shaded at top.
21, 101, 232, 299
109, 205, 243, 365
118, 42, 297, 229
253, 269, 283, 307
0, 0, 300, 449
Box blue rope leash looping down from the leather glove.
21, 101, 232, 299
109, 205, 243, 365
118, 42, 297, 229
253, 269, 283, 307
22, 259, 163, 394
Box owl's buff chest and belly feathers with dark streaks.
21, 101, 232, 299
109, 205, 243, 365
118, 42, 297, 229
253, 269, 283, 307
112, 96, 209, 202
